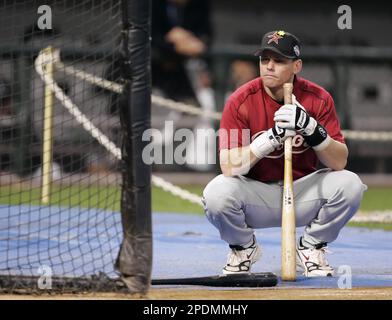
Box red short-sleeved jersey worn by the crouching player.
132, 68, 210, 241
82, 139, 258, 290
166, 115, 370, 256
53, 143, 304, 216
219, 77, 344, 182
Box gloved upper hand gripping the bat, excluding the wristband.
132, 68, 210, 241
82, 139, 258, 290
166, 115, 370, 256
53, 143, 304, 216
274, 95, 317, 136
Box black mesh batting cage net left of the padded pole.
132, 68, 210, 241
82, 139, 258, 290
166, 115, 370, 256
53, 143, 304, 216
0, 0, 138, 292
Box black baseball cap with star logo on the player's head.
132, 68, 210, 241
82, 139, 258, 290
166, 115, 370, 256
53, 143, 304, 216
255, 30, 301, 59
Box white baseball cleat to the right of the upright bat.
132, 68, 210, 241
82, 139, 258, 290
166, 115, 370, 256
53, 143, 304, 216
296, 237, 334, 277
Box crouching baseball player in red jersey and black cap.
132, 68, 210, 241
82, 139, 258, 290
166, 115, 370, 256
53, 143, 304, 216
203, 31, 366, 277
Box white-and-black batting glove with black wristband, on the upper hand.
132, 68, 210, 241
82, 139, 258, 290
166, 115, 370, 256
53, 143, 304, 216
274, 95, 331, 150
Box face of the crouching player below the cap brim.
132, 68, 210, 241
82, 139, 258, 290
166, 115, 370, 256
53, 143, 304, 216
260, 50, 300, 89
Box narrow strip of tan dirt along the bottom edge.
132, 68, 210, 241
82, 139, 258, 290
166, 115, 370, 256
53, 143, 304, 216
0, 287, 392, 300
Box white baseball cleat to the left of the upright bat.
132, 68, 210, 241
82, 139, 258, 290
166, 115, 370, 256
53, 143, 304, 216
222, 236, 261, 274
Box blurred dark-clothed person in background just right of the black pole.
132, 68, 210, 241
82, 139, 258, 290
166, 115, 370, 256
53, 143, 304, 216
151, 0, 215, 171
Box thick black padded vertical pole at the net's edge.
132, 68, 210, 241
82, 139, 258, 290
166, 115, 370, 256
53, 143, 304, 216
116, 0, 152, 293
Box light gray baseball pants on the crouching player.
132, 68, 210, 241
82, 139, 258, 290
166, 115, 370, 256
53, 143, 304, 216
202, 169, 367, 245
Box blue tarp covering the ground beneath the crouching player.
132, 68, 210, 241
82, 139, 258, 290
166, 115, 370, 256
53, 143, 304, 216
0, 206, 392, 288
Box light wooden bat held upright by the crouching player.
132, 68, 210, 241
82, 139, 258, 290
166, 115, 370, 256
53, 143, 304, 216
282, 83, 296, 281
